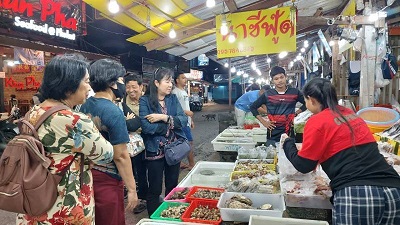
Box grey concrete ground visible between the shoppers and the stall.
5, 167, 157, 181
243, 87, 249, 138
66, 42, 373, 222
0, 103, 233, 225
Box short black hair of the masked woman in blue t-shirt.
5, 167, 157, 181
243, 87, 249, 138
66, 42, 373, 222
89, 59, 126, 92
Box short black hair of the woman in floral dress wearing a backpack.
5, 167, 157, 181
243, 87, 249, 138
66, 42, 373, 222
40, 55, 89, 100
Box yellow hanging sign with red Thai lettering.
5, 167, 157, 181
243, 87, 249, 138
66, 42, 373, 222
216, 7, 296, 58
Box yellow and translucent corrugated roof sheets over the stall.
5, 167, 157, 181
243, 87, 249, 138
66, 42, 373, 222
84, 0, 347, 59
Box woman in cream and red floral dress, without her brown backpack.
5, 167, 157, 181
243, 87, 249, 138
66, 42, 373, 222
16, 55, 113, 225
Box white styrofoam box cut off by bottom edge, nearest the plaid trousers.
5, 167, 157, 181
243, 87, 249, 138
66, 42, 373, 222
249, 215, 329, 225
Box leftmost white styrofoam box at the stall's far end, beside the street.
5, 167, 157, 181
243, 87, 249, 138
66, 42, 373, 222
211, 134, 257, 152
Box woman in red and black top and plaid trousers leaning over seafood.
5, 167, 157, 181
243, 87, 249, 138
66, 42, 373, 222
283, 78, 400, 225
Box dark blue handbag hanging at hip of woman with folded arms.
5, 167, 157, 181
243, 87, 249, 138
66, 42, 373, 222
164, 138, 190, 166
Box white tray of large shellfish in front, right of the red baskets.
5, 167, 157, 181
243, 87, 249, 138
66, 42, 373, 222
217, 192, 286, 222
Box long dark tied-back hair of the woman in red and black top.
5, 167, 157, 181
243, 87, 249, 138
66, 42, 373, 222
303, 78, 354, 137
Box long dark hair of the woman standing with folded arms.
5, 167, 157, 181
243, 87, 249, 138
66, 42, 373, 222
146, 67, 174, 112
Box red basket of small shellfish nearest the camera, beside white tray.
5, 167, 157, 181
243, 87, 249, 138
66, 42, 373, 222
182, 200, 222, 225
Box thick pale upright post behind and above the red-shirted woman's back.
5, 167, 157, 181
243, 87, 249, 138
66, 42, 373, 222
359, 25, 377, 109
